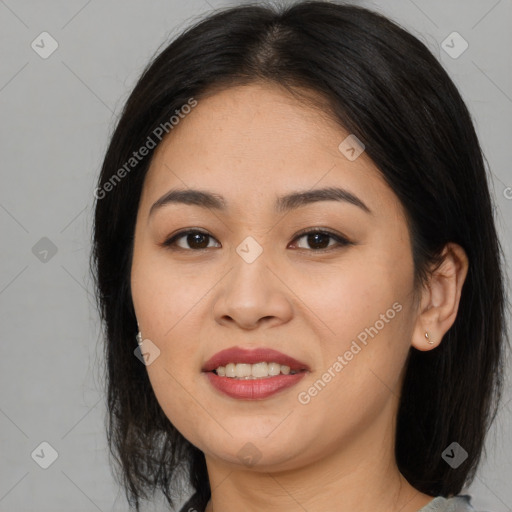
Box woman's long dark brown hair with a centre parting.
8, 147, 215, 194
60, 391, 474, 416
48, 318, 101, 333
91, 1, 508, 511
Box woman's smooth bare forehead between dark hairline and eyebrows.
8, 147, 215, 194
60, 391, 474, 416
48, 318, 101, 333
143, 84, 400, 218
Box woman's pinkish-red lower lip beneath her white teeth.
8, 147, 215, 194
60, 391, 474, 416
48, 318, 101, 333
204, 372, 307, 400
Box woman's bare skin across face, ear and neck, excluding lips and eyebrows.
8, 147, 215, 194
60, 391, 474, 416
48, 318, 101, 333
131, 83, 467, 512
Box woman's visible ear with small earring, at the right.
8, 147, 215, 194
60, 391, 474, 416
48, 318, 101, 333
411, 243, 469, 350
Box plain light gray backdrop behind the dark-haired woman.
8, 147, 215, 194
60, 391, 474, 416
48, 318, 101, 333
0, 0, 512, 512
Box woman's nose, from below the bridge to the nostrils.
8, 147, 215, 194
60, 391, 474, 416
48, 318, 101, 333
213, 247, 293, 330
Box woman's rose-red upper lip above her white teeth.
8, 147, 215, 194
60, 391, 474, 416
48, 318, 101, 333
202, 347, 309, 372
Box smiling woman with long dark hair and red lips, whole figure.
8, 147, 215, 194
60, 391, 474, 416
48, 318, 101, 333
92, 2, 506, 512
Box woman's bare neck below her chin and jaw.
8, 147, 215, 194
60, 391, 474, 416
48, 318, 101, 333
202, 404, 433, 512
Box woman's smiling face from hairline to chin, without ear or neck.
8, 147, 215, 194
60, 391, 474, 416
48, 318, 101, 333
131, 84, 416, 470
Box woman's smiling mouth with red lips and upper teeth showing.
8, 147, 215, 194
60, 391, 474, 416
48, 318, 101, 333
202, 347, 310, 400
